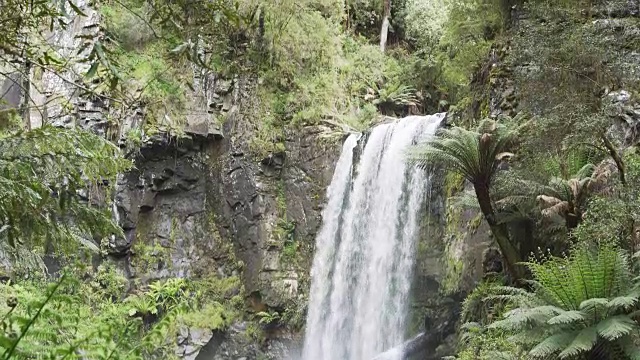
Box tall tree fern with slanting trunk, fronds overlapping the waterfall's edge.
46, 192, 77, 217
410, 120, 524, 278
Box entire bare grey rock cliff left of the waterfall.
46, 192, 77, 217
110, 79, 344, 359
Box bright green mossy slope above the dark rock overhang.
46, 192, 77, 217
98, 0, 188, 134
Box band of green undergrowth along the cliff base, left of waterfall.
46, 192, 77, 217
0, 265, 243, 360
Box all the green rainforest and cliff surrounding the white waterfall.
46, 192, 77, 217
0, 0, 640, 360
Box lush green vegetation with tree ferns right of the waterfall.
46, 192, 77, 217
410, 1, 640, 359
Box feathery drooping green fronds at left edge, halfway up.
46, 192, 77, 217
0, 126, 129, 270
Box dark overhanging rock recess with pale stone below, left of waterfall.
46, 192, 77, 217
110, 134, 222, 282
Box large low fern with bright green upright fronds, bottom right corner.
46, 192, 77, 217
489, 243, 640, 360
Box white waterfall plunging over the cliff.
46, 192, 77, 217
303, 114, 444, 360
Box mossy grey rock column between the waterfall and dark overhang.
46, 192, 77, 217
215, 105, 341, 309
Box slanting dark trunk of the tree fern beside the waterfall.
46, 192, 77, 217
474, 184, 524, 280
